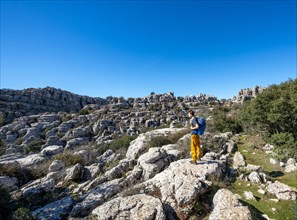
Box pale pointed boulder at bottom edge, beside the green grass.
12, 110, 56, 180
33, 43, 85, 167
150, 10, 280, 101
209, 189, 252, 220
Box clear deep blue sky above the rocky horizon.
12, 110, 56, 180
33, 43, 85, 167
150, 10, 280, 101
1, 0, 297, 98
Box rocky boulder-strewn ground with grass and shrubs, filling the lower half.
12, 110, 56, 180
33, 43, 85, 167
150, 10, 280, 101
0, 87, 297, 220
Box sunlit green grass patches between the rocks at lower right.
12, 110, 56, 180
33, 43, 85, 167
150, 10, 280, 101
230, 135, 297, 220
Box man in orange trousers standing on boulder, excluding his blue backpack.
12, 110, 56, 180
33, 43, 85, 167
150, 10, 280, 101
188, 110, 201, 164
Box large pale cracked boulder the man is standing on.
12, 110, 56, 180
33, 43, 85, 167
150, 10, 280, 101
142, 159, 225, 218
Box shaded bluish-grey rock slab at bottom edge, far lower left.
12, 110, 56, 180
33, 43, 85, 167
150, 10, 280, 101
32, 196, 73, 220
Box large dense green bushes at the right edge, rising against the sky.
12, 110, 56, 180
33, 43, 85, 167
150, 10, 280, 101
240, 79, 297, 159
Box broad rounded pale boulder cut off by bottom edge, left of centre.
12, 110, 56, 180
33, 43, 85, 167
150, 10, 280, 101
91, 194, 166, 220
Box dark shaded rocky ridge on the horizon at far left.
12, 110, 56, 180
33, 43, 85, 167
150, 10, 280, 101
0, 87, 107, 123
